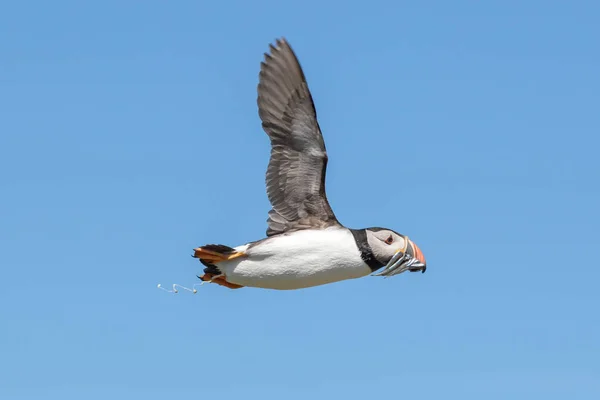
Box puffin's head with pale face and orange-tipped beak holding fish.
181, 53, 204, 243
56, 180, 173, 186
366, 228, 427, 276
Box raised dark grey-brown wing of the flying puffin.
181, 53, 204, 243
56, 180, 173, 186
258, 39, 339, 236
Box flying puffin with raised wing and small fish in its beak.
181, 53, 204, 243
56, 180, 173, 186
192, 37, 427, 290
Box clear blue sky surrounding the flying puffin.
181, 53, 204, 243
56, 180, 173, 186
0, 0, 600, 400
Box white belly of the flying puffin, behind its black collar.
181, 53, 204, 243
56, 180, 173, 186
218, 227, 371, 289
